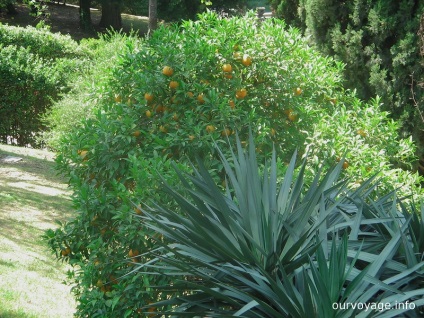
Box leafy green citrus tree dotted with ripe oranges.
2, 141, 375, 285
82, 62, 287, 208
46, 13, 420, 317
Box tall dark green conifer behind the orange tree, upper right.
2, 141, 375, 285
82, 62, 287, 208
271, 0, 424, 164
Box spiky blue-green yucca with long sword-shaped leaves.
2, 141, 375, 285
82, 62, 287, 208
136, 133, 424, 318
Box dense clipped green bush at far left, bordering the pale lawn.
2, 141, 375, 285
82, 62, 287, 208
0, 24, 88, 146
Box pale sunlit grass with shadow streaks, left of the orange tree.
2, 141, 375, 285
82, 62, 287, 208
0, 145, 75, 318
